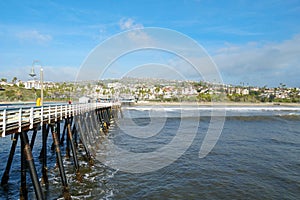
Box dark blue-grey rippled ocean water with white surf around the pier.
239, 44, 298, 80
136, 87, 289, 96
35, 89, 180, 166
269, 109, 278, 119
0, 106, 300, 199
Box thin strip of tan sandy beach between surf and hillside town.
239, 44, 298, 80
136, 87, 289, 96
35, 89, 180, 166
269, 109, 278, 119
132, 101, 300, 107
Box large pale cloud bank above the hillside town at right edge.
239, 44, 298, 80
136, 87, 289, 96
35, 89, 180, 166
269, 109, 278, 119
213, 35, 300, 86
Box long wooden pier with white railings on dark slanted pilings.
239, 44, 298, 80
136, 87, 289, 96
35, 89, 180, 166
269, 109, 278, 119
0, 103, 120, 199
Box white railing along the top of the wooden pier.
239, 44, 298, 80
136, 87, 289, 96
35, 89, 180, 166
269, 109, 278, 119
0, 103, 120, 137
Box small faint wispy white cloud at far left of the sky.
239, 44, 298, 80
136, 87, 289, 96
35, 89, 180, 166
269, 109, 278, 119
17, 30, 52, 44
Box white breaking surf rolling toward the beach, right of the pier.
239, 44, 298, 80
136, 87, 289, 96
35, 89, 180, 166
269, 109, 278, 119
122, 106, 300, 119
